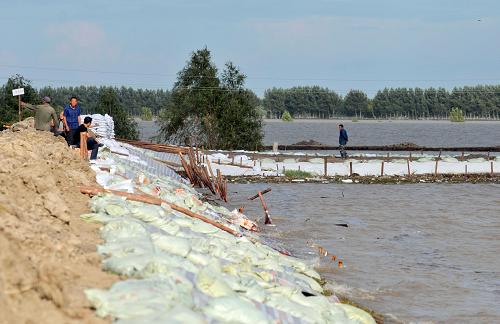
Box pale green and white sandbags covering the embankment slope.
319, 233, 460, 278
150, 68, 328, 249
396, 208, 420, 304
81, 146, 374, 324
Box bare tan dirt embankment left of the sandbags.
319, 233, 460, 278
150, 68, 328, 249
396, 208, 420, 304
0, 129, 116, 323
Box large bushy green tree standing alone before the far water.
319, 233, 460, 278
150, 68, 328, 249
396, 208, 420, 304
159, 48, 262, 149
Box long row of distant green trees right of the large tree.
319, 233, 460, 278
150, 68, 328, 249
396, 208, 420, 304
262, 85, 500, 119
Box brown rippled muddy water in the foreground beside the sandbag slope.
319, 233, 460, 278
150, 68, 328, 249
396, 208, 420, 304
230, 184, 500, 323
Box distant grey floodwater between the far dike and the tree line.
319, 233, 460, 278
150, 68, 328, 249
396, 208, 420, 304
138, 120, 500, 147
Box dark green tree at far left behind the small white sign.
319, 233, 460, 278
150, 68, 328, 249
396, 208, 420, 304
0, 74, 41, 127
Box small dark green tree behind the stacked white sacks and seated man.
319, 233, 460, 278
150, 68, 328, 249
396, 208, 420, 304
95, 87, 139, 139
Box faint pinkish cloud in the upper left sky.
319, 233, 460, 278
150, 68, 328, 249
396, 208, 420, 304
46, 21, 120, 63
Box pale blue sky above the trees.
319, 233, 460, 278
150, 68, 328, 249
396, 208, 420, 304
0, 0, 500, 96
